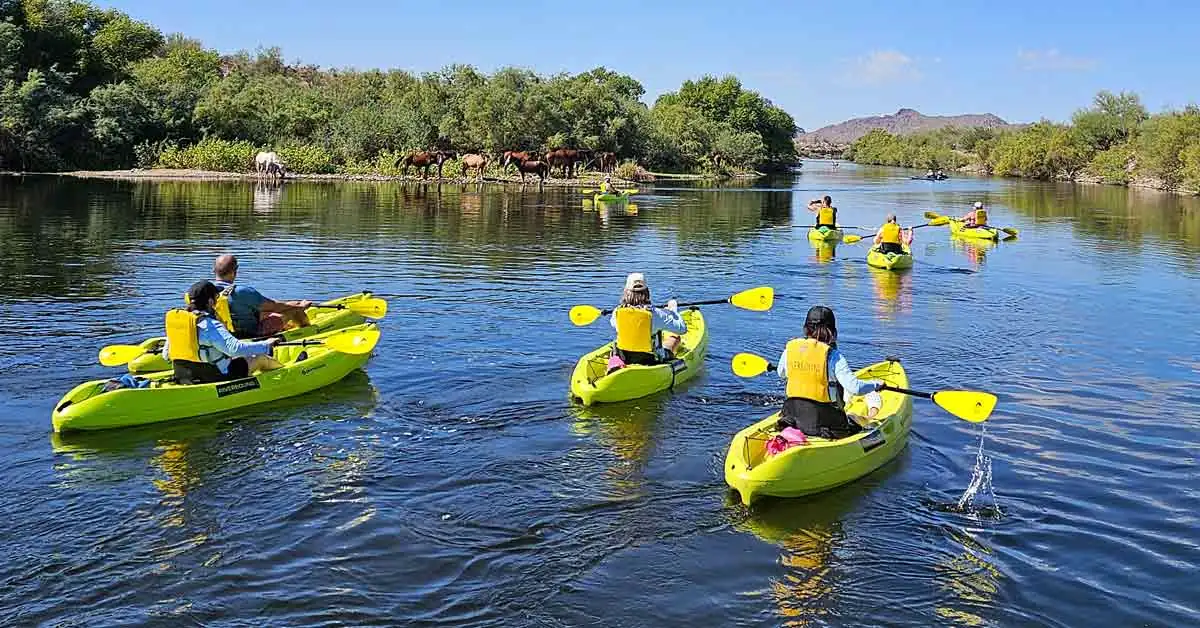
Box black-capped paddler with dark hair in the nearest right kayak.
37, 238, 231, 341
778, 305, 883, 438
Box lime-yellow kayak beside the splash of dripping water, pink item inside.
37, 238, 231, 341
725, 361, 912, 504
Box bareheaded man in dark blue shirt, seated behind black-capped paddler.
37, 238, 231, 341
212, 255, 312, 337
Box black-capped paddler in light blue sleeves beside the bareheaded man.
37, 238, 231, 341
162, 281, 281, 384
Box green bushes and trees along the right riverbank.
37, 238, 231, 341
847, 91, 1200, 191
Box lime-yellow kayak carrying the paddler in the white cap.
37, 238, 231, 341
571, 310, 708, 406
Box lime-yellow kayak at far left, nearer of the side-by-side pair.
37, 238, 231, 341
52, 323, 376, 432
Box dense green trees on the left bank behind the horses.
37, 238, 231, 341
0, 0, 796, 172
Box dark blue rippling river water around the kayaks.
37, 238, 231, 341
0, 162, 1200, 626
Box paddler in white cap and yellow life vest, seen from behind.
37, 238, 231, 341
608, 273, 688, 371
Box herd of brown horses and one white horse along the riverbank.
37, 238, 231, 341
254, 148, 617, 185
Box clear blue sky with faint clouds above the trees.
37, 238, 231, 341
100, 0, 1200, 130
